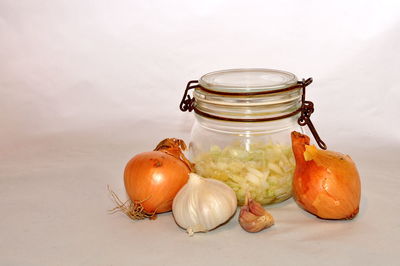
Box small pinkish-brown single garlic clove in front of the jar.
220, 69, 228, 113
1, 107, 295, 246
239, 194, 274, 233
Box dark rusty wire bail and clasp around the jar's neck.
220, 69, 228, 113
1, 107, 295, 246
179, 78, 327, 150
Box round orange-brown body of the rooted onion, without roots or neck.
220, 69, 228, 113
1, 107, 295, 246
124, 151, 190, 214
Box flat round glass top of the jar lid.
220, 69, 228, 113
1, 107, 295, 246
199, 68, 297, 95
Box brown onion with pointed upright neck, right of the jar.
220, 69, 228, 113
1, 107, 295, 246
292, 132, 361, 220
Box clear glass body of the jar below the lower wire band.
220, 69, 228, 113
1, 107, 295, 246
189, 115, 302, 205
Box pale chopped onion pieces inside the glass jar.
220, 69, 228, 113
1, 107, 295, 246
194, 143, 295, 205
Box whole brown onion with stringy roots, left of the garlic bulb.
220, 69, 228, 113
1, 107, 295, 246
112, 139, 192, 219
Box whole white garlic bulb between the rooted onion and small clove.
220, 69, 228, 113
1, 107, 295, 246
172, 173, 237, 236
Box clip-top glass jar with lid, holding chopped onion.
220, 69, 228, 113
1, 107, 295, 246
180, 69, 324, 205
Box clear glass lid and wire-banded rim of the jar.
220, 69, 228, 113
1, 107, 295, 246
193, 68, 302, 121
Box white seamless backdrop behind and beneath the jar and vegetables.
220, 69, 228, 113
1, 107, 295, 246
0, 0, 400, 265
